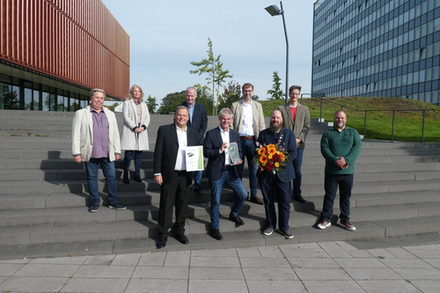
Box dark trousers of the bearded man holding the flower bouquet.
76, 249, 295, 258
258, 174, 291, 231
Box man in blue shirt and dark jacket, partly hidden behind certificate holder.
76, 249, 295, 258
182, 87, 208, 193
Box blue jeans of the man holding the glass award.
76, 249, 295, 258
209, 168, 247, 229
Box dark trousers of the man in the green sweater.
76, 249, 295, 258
321, 173, 353, 224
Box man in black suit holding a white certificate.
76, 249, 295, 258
153, 106, 203, 248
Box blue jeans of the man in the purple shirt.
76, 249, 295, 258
85, 158, 117, 205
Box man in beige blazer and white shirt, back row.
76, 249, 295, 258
231, 83, 266, 205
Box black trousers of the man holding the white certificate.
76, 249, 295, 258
158, 171, 191, 235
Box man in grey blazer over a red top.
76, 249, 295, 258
278, 85, 310, 203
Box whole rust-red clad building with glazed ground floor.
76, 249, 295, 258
0, 0, 130, 111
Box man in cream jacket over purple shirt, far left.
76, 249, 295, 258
72, 89, 126, 213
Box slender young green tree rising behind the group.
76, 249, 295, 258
189, 38, 232, 113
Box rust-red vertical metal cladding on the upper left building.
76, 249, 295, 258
0, 0, 130, 97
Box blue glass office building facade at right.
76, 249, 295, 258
312, 0, 440, 105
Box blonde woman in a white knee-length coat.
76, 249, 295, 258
121, 84, 150, 184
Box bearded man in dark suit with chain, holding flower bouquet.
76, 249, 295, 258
257, 110, 296, 239
